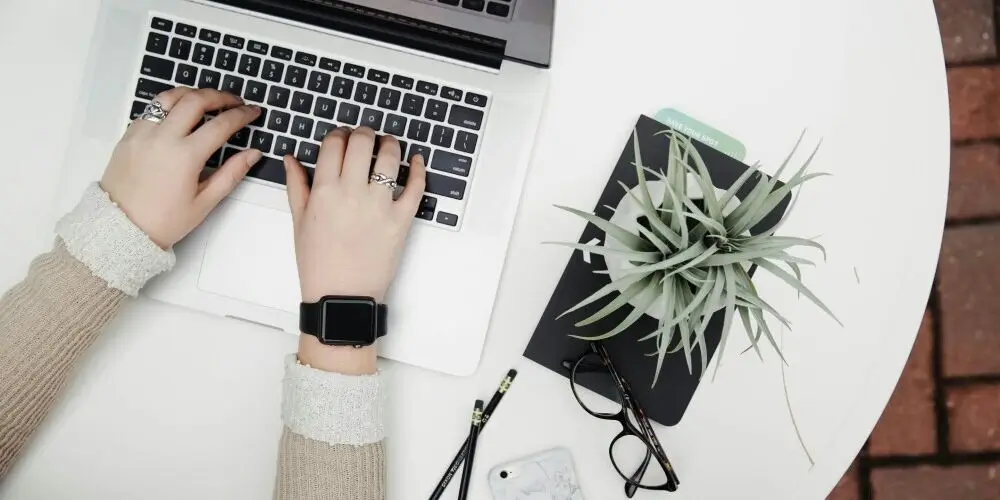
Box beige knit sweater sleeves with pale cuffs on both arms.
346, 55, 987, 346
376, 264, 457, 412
0, 184, 385, 500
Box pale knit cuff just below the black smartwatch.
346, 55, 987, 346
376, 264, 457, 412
281, 354, 385, 446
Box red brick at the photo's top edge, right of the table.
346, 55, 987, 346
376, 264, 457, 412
934, 0, 997, 62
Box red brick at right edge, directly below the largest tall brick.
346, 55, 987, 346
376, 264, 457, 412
948, 385, 1000, 452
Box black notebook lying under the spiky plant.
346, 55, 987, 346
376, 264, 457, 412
524, 116, 791, 425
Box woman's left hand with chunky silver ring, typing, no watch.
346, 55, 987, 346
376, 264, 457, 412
101, 87, 261, 248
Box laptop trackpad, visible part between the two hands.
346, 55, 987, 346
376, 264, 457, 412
198, 198, 300, 312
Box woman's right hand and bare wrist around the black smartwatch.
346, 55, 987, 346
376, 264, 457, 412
285, 127, 426, 374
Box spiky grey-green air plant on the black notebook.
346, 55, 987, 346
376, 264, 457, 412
558, 129, 840, 385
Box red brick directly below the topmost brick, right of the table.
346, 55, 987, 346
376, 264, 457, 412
948, 66, 1000, 140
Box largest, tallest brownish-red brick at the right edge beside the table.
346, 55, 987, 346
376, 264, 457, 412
939, 224, 1000, 376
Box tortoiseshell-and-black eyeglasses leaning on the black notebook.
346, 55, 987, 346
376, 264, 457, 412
562, 342, 680, 498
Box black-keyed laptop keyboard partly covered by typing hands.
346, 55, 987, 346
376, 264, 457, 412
130, 15, 490, 230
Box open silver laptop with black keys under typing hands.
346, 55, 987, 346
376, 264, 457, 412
57, 0, 554, 375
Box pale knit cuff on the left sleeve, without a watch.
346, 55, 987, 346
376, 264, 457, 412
56, 182, 175, 296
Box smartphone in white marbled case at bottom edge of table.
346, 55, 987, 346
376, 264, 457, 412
489, 448, 583, 500
